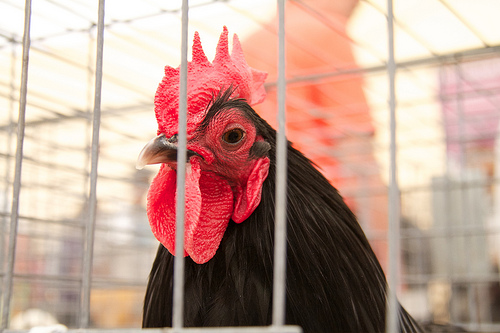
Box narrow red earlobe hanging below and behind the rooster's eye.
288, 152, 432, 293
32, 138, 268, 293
231, 157, 270, 223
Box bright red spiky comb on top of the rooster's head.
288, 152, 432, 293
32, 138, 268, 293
155, 27, 267, 137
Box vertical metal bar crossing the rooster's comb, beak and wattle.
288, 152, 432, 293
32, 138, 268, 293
172, 0, 189, 330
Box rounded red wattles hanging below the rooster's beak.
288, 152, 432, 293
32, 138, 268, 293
148, 158, 233, 264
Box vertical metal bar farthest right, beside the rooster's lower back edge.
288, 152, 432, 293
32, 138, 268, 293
386, 0, 401, 333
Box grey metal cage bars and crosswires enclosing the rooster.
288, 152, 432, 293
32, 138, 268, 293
0, 0, 500, 333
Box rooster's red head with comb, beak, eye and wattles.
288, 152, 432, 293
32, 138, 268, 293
138, 27, 270, 264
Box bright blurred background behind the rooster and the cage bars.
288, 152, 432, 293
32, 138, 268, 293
0, 0, 500, 332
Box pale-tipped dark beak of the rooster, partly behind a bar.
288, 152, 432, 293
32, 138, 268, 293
135, 134, 198, 170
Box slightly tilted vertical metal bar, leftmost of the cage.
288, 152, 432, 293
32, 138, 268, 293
1, 0, 31, 331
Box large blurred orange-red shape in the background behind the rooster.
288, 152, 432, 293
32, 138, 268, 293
243, 0, 387, 268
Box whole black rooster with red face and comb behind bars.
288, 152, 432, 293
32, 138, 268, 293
138, 27, 421, 332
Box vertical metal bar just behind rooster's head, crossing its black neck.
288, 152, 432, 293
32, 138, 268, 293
273, 0, 287, 326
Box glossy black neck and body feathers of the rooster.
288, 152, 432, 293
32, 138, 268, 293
143, 94, 420, 332
